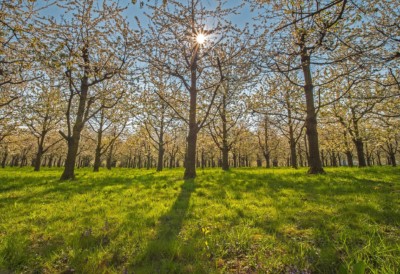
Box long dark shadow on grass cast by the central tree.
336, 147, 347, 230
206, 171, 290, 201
132, 180, 195, 273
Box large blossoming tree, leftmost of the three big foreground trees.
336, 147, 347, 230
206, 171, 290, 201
42, 0, 136, 180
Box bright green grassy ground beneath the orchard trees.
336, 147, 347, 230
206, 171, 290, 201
0, 167, 400, 273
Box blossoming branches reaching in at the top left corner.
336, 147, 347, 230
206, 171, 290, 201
0, 0, 46, 108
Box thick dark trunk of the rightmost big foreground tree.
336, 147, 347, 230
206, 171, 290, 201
301, 52, 324, 174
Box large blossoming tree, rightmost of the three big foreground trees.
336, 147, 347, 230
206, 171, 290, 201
255, 0, 355, 174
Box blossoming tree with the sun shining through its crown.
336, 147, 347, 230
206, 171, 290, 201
144, 0, 241, 179
